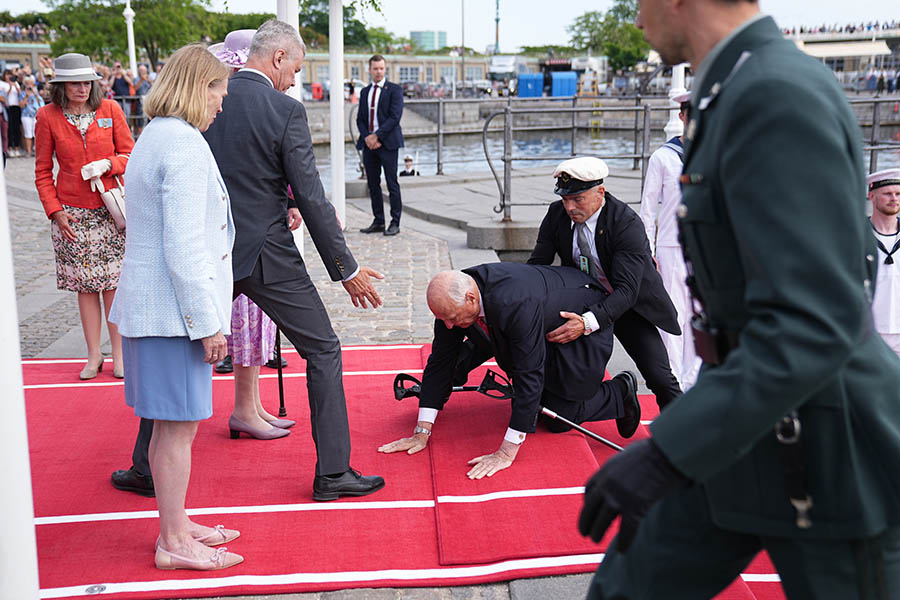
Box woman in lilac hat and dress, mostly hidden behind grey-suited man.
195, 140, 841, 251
209, 29, 299, 440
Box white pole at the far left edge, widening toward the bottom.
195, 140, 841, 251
0, 155, 39, 600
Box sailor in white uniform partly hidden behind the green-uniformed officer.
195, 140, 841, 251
640, 92, 702, 391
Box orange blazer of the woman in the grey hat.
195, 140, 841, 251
34, 100, 134, 218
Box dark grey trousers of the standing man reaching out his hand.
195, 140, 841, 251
234, 255, 350, 475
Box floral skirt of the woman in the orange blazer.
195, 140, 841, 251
50, 205, 125, 293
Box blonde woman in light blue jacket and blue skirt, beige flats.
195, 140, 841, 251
110, 45, 243, 570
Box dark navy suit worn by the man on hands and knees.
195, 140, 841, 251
419, 263, 624, 433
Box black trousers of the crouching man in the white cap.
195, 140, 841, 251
613, 310, 681, 410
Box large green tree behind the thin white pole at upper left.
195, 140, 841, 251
45, 0, 206, 68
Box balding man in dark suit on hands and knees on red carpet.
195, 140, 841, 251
378, 263, 641, 479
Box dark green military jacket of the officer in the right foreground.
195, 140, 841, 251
651, 18, 900, 538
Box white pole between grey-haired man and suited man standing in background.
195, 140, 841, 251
328, 0, 347, 228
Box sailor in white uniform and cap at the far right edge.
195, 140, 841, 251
866, 169, 900, 355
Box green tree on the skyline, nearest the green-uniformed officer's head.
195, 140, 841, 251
566, 0, 650, 72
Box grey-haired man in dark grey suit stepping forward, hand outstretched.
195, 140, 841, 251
204, 20, 384, 500
